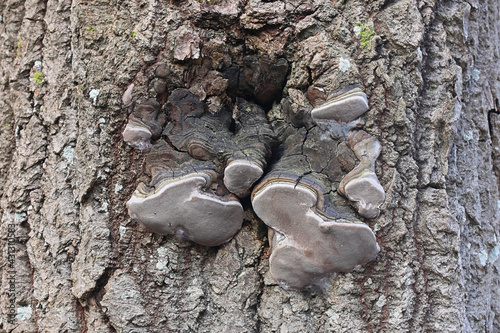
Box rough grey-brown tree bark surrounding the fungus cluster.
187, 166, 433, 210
0, 0, 500, 332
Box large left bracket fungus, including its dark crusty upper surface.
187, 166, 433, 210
127, 140, 243, 246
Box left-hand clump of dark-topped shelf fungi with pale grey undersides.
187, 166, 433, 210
123, 65, 275, 246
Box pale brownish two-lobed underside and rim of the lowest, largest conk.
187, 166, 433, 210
252, 179, 379, 289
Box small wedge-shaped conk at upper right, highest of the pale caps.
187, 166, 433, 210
311, 86, 369, 123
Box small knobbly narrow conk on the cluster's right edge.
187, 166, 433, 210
338, 131, 385, 219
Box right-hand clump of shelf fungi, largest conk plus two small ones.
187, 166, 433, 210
252, 80, 385, 290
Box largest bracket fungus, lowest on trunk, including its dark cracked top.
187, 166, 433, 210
252, 123, 379, 289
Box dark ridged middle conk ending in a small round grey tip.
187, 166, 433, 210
164, 89, 274, 197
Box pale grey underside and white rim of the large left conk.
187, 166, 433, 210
127, 172, 243, 246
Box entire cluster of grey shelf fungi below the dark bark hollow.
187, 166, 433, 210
123, 65, 385, 290
